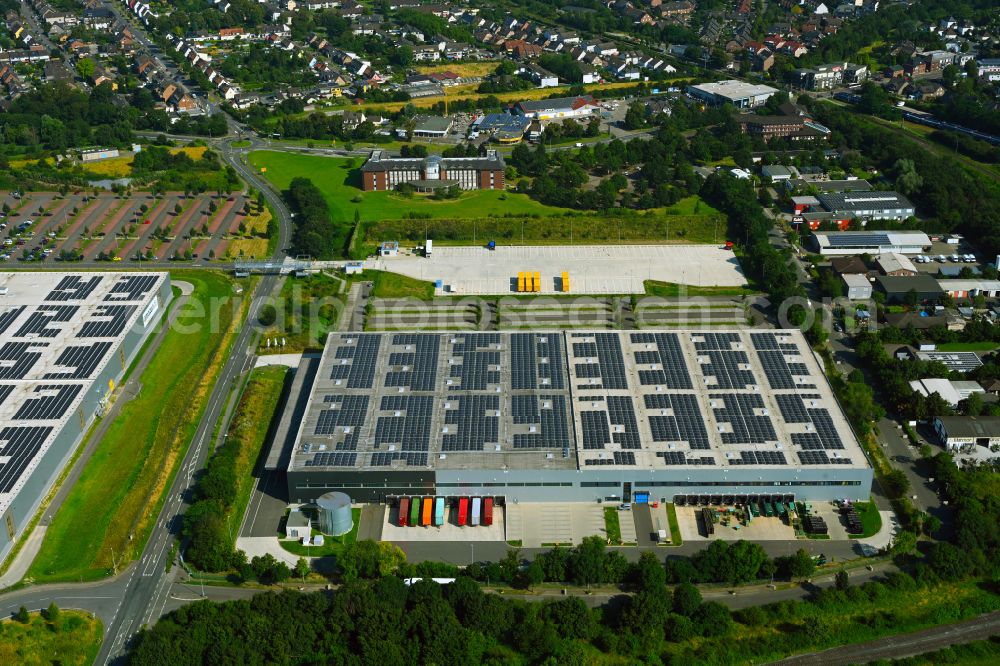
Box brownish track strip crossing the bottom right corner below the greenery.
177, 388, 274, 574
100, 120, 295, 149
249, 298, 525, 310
774, 612, 1000, 666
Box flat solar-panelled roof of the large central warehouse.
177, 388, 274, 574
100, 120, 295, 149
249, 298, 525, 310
289, 330, 867, 471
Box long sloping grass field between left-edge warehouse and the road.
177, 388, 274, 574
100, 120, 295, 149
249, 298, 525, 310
28, 271, 249, 582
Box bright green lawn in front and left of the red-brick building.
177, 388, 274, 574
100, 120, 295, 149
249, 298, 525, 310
249, 151, 566, 224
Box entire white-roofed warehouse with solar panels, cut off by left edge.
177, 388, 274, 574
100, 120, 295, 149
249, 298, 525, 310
0, 273, 171, 559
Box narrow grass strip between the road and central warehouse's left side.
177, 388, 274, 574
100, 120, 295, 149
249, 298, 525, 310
226, 365, 290, 534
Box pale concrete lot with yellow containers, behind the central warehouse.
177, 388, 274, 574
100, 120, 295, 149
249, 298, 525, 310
365, 245, 746, 294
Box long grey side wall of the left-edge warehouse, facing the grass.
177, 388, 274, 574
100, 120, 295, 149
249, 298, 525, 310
0, 275, 172, 561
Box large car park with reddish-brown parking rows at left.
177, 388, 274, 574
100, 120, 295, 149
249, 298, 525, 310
0, 191, 258, 261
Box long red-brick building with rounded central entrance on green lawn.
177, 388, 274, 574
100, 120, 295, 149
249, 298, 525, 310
361, 150, 506, 192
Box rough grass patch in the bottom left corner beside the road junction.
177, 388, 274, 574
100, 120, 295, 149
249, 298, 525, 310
0, 610, 104, 666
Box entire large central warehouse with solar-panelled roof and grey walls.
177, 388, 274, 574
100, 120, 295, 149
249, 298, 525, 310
278, 330, 872, 502
